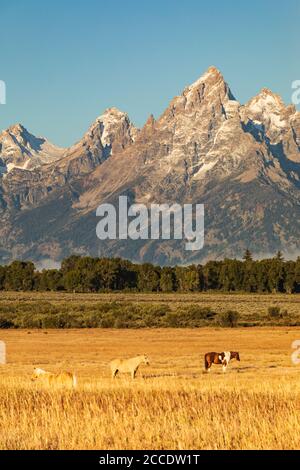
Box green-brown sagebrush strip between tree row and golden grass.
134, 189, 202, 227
0, 292, 300, 329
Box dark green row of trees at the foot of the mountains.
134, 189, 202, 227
0, 250, 300, 293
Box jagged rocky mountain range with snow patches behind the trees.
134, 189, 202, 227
0, 67, 300, 264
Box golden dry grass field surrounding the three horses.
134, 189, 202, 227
0, 327, 300, 450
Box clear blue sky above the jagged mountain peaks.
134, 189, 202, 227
0, 0, 300, 146
